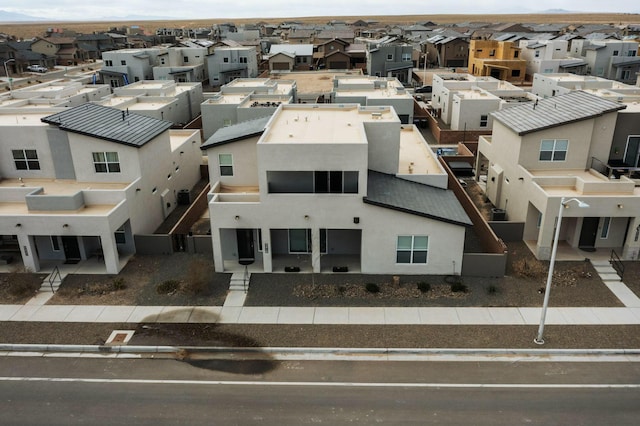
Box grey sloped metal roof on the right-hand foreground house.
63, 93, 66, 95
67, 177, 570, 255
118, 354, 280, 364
491, 91, 627, 136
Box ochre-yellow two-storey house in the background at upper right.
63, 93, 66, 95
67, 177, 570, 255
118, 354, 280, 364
469, 40, 527, 84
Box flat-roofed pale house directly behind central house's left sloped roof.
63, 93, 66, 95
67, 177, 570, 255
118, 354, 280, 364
201, 78, 297, 140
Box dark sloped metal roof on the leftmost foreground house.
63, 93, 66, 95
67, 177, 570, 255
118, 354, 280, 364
42, 103, 172, 148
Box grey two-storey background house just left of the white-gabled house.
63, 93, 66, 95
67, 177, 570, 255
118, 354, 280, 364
207, 46, 258, 86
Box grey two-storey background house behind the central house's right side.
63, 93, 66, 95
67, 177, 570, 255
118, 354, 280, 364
367, 37, 414, 84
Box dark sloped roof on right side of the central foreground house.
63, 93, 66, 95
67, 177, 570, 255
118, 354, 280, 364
364, 170, 472, 226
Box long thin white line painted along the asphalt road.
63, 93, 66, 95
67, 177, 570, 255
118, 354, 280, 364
0, 377, 640, 389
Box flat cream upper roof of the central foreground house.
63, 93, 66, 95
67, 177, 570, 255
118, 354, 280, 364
259, 104, 398, 144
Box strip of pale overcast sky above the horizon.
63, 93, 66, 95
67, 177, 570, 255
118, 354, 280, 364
0, 0, 640, 21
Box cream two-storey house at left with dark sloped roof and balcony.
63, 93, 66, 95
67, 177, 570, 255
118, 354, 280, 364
0, 103, 202, 274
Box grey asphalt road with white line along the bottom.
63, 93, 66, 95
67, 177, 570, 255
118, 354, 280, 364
0, 357, 640, 425
